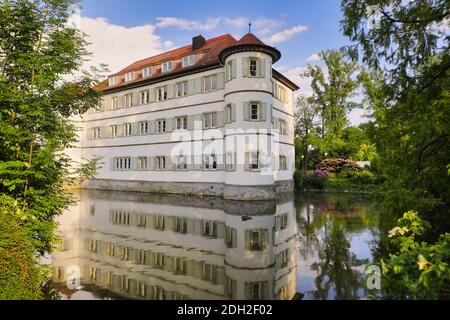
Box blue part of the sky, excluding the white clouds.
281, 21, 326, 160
82, 0, 347, 68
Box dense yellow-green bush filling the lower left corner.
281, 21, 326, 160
0, 196, 41, 300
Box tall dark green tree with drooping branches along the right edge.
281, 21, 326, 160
342, 0, 450, 235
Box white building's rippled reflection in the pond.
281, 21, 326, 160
53, 191, 296, 300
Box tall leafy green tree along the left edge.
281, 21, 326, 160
0, 0, 99, 252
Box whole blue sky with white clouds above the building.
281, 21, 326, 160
79, 0, 362, 124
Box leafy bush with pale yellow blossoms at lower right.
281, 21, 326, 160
381, 211, 450, 299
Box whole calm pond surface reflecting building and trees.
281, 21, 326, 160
48, 190, 379, 300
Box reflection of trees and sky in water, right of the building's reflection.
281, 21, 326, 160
296, 194, 379, 299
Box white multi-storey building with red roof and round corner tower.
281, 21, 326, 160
71, 33, 298, 200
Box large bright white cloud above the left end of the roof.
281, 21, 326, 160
77, 17, 164, 73
